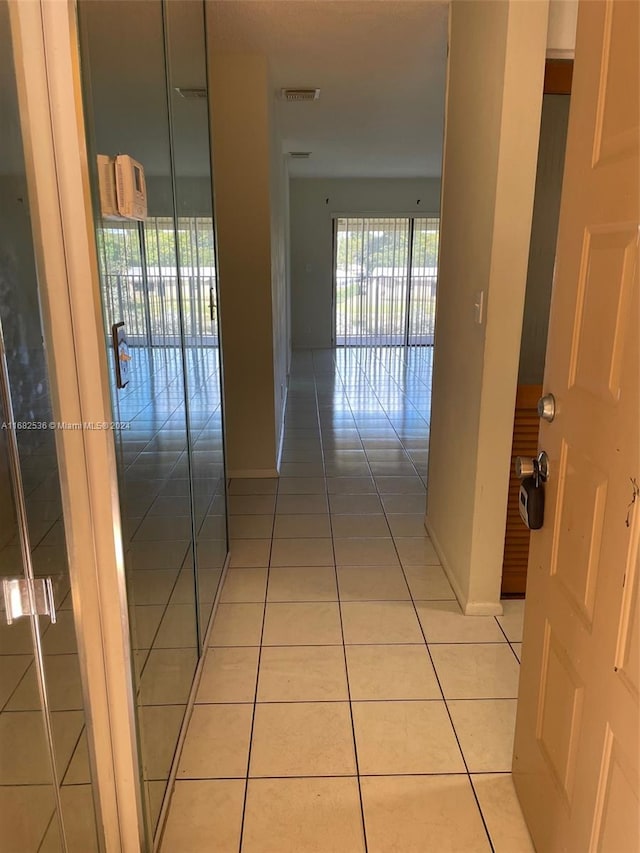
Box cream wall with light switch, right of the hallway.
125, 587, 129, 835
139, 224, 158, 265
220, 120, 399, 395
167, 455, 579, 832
426, 0, 548, 613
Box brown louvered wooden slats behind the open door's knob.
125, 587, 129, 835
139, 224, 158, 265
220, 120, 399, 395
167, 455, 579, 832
502, 385, 542, 595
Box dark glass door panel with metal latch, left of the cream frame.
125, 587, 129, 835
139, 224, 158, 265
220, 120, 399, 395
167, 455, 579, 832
0, 5, 98, 853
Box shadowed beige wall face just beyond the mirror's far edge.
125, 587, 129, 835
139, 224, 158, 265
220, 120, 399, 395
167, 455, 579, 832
208, 51, 277, 477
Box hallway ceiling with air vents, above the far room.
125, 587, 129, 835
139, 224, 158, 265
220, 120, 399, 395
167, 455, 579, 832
209, 0, 448, 177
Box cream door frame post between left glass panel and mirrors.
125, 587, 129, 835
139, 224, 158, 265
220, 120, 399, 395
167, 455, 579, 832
9, 0, 145, 853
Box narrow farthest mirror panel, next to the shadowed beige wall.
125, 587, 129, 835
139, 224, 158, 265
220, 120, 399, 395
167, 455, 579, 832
165, 0, 227, 637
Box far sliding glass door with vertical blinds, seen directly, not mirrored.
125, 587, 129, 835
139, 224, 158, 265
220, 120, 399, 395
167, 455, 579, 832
334, 216, 439, 346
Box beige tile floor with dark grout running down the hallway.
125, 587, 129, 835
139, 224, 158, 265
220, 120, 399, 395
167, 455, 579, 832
162, 348, 533, 853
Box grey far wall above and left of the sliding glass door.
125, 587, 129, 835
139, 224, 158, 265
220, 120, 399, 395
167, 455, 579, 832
290, 178, 440, 349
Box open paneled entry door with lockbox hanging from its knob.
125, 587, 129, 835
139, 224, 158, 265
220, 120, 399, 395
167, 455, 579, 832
513, 0, 640, 853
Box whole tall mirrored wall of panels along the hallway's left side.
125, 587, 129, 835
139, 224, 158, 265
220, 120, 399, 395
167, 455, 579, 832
79, 0, 227, 837
